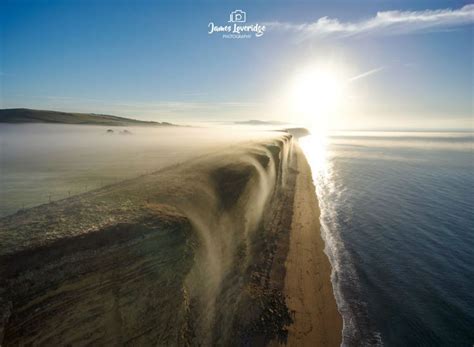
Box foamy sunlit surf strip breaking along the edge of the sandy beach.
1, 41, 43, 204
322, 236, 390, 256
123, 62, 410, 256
299, 136, 382, 346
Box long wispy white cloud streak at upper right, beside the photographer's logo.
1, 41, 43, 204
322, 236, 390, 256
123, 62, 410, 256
268, 4, 474, 40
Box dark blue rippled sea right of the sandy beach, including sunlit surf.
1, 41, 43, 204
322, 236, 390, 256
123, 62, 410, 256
300, 132, 474, 346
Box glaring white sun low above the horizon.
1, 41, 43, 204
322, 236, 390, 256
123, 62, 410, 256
291, 66, 344, 129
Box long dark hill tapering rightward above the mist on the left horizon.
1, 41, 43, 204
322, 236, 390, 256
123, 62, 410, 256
0, 108, 173, 126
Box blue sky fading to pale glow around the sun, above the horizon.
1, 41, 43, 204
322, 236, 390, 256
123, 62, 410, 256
0, 0, 474, 130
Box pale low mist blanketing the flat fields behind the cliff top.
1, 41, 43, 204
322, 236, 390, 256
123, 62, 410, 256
0, 124, 282, 216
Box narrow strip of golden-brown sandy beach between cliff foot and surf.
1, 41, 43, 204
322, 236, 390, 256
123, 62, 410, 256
284, 146, 342, 346
